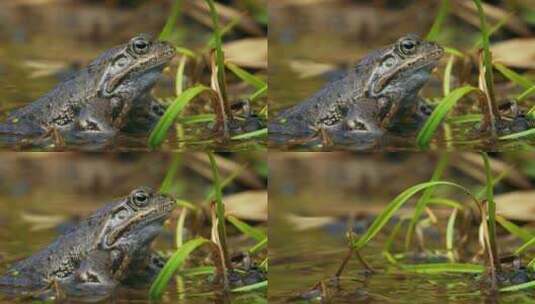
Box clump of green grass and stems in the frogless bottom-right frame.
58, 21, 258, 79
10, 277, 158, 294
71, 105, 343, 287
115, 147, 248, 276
303, 153, 535, 299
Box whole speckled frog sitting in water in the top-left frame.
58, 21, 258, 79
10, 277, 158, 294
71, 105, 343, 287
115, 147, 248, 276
0, 34, 175, 143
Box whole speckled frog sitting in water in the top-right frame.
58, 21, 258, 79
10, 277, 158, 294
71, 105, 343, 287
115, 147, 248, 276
269, 34, 444, 142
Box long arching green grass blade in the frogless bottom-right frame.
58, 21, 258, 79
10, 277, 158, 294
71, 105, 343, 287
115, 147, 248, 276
353, 181, 474, 250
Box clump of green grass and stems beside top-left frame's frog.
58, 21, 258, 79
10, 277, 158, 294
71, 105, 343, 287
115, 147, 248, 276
148, 0, 267, 149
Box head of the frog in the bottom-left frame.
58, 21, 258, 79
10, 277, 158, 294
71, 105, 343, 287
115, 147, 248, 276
96, 187, 176, 251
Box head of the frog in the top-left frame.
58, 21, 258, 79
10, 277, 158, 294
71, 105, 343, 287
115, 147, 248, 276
96, 34, 175, 98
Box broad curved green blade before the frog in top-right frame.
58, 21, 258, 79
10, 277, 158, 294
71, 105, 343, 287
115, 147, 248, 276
416, 85, 478, 149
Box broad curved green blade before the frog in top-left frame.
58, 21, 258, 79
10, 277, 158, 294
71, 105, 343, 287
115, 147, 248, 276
148, 84, 210, 149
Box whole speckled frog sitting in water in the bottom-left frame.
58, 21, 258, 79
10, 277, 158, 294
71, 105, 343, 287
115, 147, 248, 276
0, 187, 176, 297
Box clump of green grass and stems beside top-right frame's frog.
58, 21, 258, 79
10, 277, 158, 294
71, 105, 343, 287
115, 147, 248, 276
417, 0, 535, 149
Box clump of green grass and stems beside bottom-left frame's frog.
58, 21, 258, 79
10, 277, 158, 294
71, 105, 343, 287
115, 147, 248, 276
149, 153, 268, 300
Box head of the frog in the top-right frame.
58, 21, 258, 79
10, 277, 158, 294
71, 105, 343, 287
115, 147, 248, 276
357, 34, 444, 98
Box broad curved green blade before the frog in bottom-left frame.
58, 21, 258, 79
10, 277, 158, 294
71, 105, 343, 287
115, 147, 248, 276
149, 238, 210, 300
